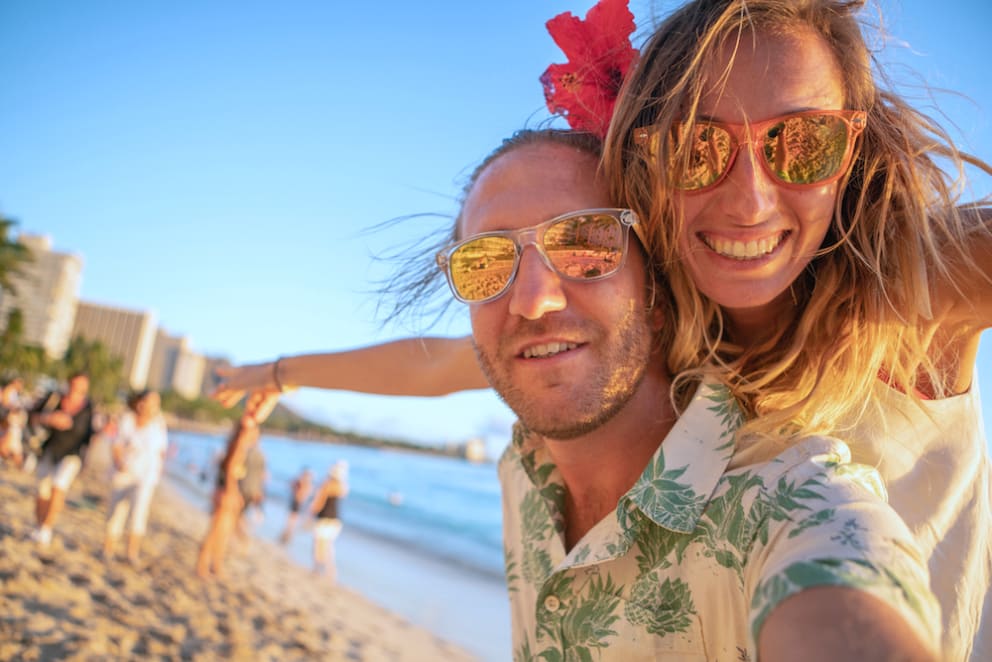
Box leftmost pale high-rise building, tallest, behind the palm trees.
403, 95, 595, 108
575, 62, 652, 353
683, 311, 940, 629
0, 234, 83, 359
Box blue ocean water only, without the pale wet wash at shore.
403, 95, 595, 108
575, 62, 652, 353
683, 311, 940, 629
169, 432, 503, 579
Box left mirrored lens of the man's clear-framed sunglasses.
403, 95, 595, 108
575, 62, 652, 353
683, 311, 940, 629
448, 237, 517, 301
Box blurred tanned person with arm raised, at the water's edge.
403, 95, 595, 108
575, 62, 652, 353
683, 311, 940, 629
196, 392, 279, 579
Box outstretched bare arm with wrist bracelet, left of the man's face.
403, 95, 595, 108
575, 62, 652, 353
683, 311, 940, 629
214, 336, 489, 406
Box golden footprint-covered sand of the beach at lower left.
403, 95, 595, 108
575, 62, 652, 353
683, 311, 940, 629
0, 456, 475, 661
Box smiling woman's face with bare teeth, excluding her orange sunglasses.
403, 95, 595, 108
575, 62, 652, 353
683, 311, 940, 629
673, 31, 844, 340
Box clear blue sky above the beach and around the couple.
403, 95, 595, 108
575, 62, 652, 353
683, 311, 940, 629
0, 0, 992, 450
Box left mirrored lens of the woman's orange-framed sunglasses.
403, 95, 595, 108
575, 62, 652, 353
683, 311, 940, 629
670, 122, 734, 191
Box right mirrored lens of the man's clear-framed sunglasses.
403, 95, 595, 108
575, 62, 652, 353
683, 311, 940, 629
543, 214, 624, 280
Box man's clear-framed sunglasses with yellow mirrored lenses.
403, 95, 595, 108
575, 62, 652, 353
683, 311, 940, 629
437, 209, 638, 303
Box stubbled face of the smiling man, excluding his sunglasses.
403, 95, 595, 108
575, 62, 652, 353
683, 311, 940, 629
459, 143, 652, 439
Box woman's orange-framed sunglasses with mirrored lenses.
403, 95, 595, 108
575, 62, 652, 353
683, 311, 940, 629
634, 110, 867, 193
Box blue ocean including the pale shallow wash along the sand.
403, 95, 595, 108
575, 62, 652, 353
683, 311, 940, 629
166, 430, 511, 662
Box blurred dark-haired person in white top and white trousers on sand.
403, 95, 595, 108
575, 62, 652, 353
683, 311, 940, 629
103, 390, 169, 563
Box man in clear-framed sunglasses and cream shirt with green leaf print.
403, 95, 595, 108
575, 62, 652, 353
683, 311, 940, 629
439, 132, 939, 660
